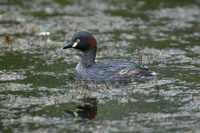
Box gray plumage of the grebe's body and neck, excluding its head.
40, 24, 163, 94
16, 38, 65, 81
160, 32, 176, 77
75, 49, 155, 82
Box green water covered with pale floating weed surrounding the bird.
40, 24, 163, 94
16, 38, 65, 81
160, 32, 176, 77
0, 0, 200, 133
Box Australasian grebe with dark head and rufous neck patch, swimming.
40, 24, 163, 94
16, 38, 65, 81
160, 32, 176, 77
63, 31, 155, 82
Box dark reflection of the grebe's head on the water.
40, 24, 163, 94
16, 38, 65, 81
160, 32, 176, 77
65, 97, 97, 119
